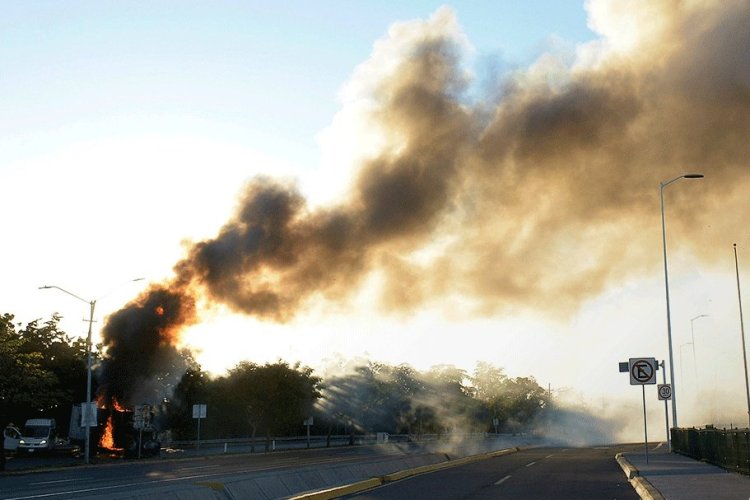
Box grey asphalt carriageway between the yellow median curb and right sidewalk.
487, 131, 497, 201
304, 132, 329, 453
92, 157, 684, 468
347, 445, 639, 500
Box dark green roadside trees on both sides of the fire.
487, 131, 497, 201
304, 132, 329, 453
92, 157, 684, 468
0, 314, 549, 448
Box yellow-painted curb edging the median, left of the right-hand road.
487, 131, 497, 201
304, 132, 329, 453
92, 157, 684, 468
289, 446, 521, 500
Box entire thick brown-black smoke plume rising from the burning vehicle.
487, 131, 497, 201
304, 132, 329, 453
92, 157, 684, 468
98, 0, 750, 406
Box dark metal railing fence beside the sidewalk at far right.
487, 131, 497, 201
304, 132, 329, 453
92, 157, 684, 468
671, 427, 750, 475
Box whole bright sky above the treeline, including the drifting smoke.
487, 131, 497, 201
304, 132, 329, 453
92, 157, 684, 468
0, 0, 750, 438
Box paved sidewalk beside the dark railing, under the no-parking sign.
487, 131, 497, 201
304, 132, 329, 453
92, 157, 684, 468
622, 447, 750, 500
